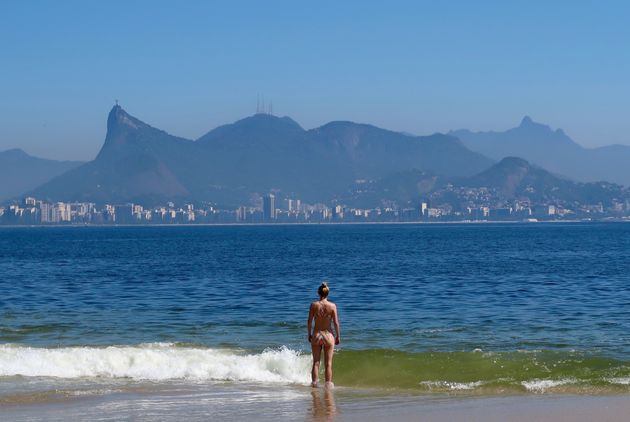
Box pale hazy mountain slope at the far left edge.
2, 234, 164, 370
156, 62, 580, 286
0, 149, 83, 201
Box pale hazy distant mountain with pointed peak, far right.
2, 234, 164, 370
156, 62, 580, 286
449, 116, 630, 185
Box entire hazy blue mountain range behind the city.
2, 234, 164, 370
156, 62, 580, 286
0, 105, 630, 207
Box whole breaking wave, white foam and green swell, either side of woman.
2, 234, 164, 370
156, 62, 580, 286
0, 343, 630, 394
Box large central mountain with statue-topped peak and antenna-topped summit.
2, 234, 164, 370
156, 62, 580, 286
32, 106, 492, 206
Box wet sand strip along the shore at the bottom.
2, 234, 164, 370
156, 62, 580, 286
0, 383, 630, 422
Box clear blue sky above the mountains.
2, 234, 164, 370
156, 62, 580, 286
0, 0, 630, 160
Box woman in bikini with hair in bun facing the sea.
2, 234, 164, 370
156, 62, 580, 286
308, 282, 341, 387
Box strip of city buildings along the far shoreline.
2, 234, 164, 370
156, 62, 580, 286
0, 194, 630, 225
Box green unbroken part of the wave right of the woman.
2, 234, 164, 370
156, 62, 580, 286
335, 349, 630, 394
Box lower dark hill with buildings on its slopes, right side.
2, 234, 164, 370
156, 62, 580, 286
342, 157, 630, 211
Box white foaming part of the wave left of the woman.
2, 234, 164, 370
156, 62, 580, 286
0, 343, 310, 384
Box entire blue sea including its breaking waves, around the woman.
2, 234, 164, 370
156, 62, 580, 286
0, 223, 630, 405
